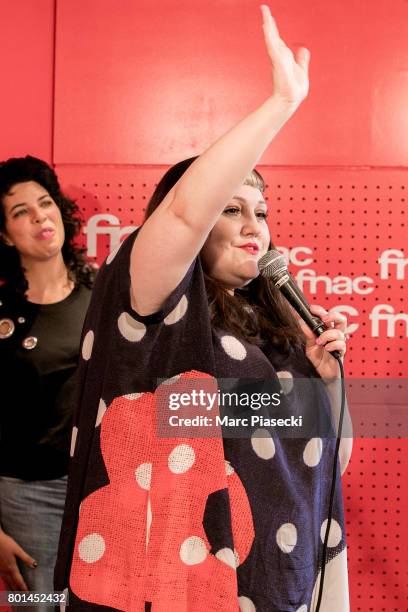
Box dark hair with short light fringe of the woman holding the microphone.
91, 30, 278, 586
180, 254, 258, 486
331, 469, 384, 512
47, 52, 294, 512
145, 157, 305, 354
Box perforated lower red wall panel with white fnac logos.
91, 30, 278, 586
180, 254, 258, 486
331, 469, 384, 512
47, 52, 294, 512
57, 161, 408, 612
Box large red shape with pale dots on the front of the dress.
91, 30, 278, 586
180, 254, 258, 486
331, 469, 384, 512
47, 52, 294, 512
70, 371, 254, 612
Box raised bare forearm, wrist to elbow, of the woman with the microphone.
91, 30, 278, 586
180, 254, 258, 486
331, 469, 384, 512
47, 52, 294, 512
171, 96, 298, 227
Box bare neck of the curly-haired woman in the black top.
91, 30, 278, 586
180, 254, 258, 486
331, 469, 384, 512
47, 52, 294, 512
21, 253, 74, 304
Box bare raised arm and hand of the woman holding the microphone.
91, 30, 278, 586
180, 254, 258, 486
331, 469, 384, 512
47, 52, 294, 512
130, 5, 309, 315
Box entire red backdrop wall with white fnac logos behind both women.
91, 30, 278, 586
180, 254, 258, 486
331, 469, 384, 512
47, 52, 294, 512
0, 0, 408, 612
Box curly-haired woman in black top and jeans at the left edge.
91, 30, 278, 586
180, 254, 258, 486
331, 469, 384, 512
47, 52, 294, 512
0, 156, 93, 610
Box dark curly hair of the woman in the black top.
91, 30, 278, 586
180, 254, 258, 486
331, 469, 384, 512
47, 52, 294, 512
0, 155, 95, 295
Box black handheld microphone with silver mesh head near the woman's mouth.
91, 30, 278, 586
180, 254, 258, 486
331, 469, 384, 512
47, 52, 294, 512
258, 250, 340, 359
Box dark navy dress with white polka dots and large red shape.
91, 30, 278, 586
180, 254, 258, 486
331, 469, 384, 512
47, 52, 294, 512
56, 231, 349, 612
